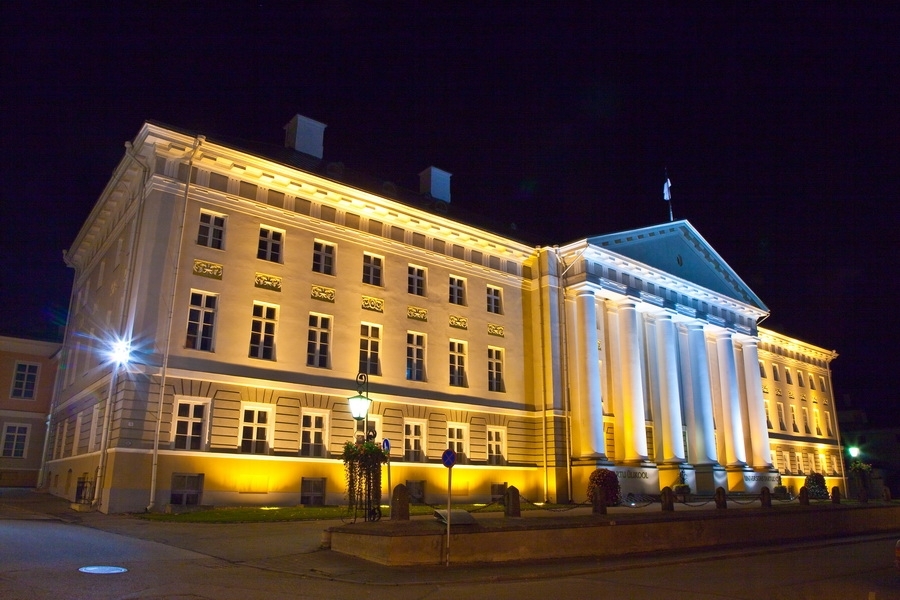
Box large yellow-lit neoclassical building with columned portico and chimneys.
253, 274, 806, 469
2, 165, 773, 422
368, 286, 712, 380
46, 115, 837, 512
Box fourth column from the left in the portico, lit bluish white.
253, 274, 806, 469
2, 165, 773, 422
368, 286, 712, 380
684, 322, 718, 465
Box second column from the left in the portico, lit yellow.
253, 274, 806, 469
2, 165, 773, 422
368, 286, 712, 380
618, 302, 647, 461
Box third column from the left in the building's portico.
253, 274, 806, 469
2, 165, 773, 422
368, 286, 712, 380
655, 315, 684, 463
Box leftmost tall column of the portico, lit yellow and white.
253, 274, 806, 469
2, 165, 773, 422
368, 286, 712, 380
575, 290, 606, 458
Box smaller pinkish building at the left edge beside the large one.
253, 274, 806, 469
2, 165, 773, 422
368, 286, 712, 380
0, 336, 61, 487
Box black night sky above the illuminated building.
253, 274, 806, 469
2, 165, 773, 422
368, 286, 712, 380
0, 1, 900, 423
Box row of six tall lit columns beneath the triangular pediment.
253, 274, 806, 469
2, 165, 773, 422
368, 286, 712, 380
568, 290, 772, 468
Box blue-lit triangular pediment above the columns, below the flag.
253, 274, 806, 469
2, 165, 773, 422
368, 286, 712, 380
587, 220, 769, 312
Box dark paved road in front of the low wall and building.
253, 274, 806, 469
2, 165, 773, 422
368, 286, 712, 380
0, 490, 900, 600
